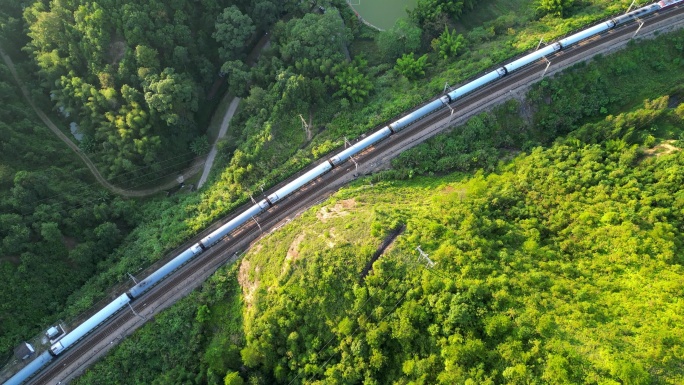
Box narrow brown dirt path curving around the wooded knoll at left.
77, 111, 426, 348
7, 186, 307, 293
0, 46, 204, 198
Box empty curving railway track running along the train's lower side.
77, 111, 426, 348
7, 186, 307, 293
24, 3, 684, 384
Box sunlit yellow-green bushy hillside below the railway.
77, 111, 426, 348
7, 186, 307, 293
73, 102, 684, 384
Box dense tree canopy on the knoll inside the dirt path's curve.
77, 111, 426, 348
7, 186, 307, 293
23, 0, 298, 178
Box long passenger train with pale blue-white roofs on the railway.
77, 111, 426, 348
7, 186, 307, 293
5, 0, 684, 385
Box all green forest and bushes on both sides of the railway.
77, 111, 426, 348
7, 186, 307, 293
0, 0, 684, 384
